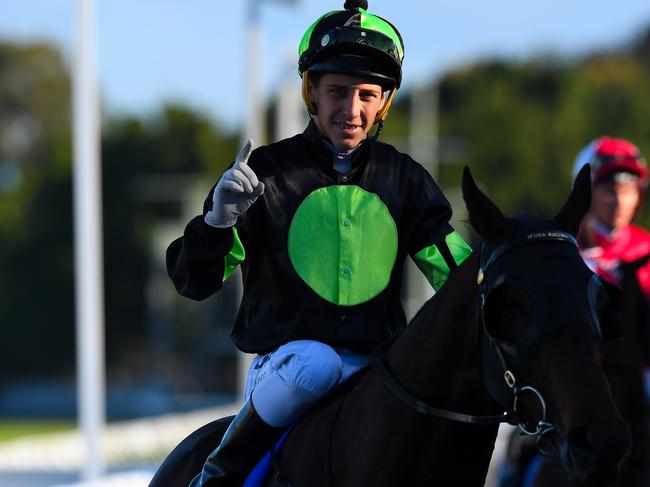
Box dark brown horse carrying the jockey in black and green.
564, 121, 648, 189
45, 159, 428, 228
151, 169, 630, 487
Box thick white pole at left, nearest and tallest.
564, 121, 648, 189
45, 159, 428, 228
73, 0, 106, 484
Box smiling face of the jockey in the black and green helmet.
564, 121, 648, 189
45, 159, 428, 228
311, 73, 385, 151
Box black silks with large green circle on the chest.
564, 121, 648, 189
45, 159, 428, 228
167, 125, 471, 353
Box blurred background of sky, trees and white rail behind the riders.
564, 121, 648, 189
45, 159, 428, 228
0, 0, 650, 486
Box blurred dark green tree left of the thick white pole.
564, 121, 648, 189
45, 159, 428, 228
0, 42, 74, 378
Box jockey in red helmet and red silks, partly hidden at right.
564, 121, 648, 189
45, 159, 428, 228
573, 137, 650, 298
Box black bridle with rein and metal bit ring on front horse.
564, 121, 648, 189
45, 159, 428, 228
372, 230, 577, 456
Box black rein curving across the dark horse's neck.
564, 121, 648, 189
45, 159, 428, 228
372, 356, 519, 425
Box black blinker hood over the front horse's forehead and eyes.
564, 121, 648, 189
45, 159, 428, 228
480, 217, 602, 358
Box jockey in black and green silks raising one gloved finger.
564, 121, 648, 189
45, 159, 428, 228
167, 0, 471, 486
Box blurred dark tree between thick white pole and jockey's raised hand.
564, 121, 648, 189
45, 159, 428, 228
102, 105, 239, 374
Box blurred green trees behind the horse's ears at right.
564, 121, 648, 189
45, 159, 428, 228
432, 28, 650, 229
